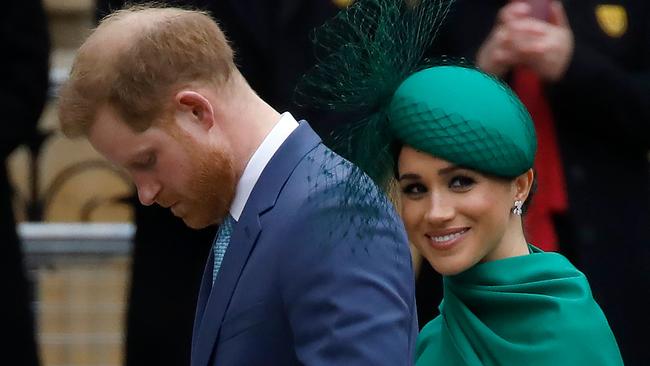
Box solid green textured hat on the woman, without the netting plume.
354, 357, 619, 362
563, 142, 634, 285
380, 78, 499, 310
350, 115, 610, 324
387, 66, 537, 177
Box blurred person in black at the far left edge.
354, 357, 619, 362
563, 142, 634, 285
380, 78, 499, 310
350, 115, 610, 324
0, 0, 50, 366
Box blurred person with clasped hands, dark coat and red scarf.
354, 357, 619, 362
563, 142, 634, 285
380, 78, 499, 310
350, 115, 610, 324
417, 0, 650, 365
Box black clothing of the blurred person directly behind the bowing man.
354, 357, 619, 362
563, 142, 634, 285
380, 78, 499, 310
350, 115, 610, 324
97, 0, 337, 365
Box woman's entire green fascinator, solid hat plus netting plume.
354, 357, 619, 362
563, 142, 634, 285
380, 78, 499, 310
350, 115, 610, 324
298, 0, 537, 191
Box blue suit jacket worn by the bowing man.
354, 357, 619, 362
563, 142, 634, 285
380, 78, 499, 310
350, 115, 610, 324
191, 122, 417, 366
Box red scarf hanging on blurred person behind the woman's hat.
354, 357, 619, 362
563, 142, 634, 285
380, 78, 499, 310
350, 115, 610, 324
512, 68, 567, 251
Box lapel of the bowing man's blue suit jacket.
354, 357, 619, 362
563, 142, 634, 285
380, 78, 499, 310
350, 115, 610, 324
192, 122, 320, 366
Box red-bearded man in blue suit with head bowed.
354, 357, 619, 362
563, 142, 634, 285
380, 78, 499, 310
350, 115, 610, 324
59, 7, 417, 366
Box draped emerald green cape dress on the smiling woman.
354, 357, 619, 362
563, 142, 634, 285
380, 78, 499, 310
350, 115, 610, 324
416, 246, 623, 366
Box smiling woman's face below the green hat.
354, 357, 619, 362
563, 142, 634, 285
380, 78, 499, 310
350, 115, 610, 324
398, 146, 532, 275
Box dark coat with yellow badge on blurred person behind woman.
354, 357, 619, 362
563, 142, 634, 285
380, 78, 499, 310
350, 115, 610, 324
418, 0, 650, 365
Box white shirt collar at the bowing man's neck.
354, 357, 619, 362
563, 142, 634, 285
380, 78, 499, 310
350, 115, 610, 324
230, 112, 298, 221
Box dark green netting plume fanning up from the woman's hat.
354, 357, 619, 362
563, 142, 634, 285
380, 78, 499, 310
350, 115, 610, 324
297, 0, 453, 194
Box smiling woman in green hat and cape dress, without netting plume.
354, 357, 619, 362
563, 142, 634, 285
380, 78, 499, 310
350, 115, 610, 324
388, 66, 622, 365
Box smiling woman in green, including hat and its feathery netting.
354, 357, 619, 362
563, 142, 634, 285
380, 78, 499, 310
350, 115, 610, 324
300, 0, 623, 366
